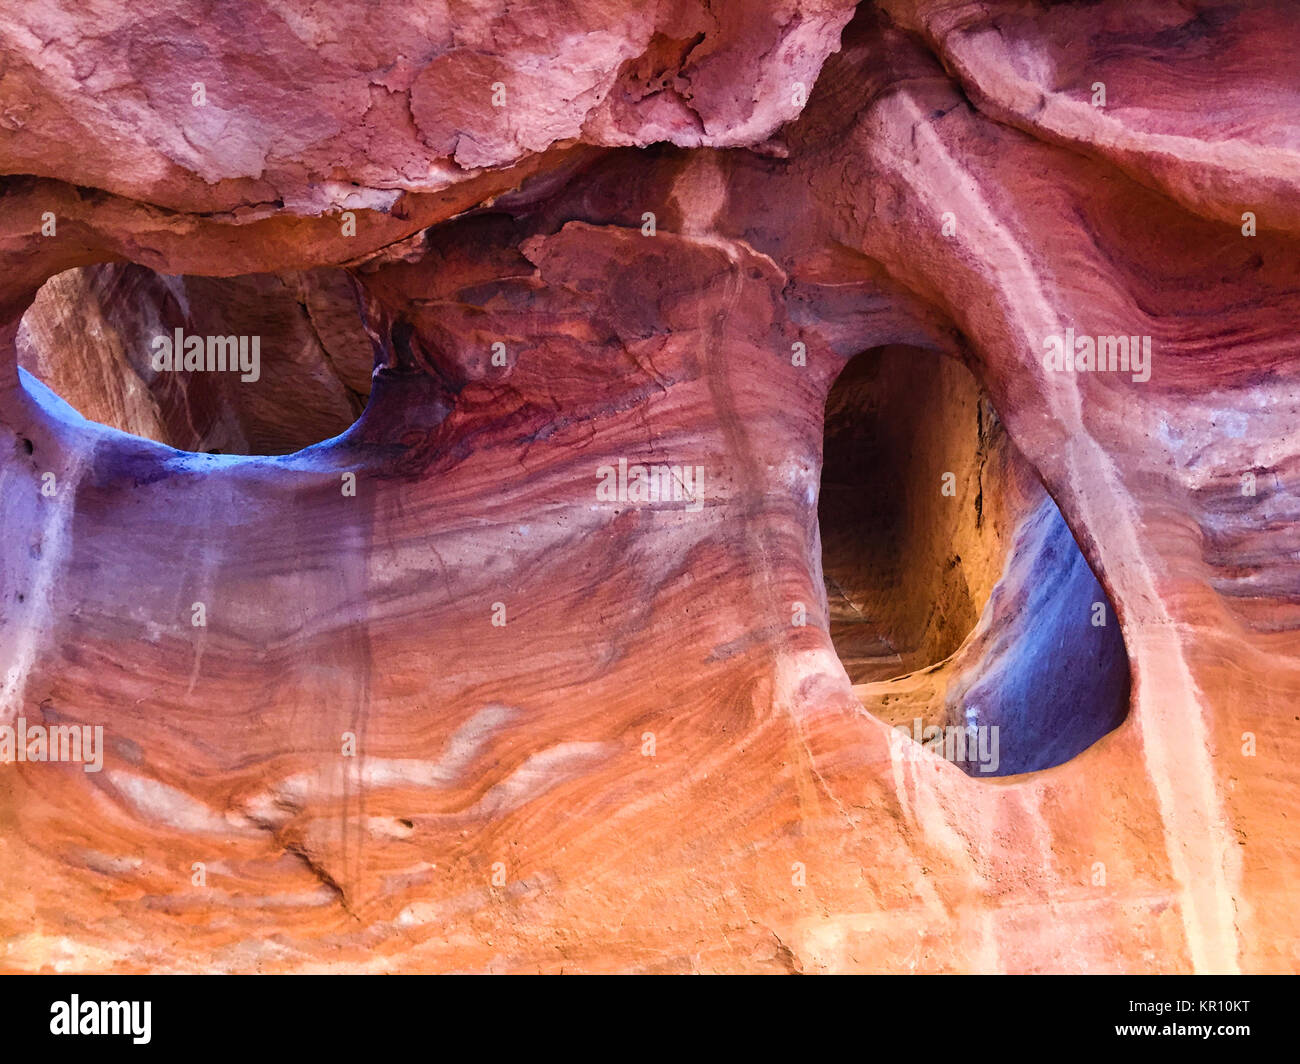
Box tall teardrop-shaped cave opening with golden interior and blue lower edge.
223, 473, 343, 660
818, 346, 1130, 777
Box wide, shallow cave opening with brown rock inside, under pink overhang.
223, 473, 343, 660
17, 263, 374, 455
